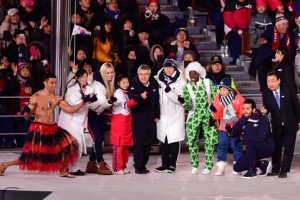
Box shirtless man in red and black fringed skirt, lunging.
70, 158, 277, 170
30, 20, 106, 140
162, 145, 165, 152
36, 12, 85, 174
0, 73, 89, 178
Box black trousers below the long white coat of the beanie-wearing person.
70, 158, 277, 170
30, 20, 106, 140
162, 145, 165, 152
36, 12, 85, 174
161, 136, 180, 169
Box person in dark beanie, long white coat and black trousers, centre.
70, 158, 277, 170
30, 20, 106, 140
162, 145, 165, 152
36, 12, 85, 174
154, 53, 186, 173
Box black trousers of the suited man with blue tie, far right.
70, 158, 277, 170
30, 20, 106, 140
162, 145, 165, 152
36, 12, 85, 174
272, 126, 297, 172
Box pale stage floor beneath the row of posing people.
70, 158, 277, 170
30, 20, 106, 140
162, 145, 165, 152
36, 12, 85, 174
0, 151, 300, 200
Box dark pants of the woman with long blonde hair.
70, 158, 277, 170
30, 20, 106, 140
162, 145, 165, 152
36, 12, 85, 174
88, 110, 105, 162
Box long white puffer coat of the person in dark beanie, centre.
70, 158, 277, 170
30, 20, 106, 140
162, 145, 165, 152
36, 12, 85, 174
154, 69, 186, 143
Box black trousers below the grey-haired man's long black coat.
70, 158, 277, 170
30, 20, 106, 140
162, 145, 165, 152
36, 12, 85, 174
133, 144, 151, 171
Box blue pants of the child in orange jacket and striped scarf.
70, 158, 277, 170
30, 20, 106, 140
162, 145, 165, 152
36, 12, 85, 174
217, 131, 243, 162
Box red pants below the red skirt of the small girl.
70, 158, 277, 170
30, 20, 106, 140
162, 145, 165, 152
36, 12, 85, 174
112, 146, 129, 172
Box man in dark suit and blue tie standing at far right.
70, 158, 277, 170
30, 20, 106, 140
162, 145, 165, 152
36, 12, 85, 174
261, 72, 300, 178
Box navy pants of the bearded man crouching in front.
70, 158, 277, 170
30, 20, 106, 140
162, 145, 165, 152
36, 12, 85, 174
233, 142, 274, 172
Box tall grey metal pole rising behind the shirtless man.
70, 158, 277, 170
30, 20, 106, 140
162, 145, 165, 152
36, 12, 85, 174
50, 0, 71, 121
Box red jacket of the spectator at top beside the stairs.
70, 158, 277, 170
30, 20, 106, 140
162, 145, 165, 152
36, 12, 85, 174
223, 0, 255, 34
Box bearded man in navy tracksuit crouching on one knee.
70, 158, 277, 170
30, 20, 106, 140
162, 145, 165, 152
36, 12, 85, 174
229, 99, 275, 179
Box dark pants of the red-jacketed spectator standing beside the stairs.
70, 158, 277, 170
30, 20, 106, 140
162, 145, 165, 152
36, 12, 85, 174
227, 31, 242, 63
